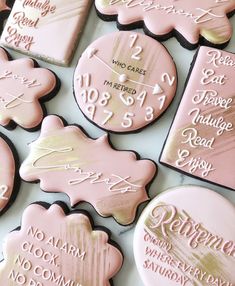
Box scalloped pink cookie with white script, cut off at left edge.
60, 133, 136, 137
0, 48, 58, 130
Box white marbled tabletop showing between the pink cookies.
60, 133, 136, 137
0, 7, 235, 286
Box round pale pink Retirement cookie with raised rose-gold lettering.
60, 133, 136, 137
134, 186, 235, 286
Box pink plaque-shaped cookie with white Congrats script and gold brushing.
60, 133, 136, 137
20, 116, 156, 225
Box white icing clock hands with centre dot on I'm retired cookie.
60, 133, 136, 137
87, 48, 163, 94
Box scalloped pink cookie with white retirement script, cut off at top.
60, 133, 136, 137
95, 0, 235, 49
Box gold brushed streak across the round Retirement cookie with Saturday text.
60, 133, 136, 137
145, 202, 234, 286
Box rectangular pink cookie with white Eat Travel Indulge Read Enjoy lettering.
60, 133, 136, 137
160, 47, 235, 190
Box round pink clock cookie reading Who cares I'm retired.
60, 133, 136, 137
74, 32, 177, 132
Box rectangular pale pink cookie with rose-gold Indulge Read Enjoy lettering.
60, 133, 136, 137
1, 0, 91, 66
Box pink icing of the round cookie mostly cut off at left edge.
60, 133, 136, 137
0, 135, 15, 213
